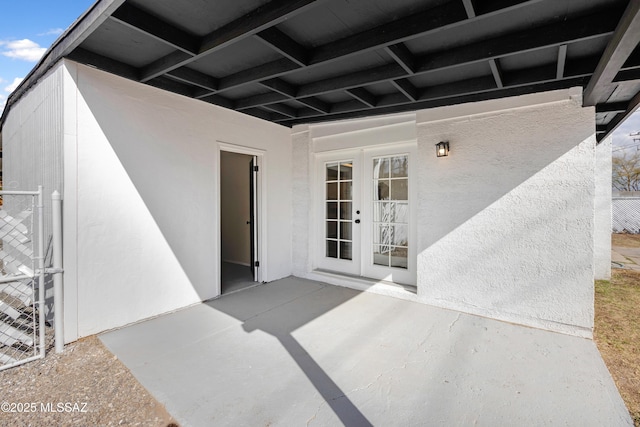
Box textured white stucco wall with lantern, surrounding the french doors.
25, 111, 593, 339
293, 89, 596, 337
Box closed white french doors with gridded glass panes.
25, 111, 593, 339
316, 144, 416, 285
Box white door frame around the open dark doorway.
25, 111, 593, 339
214, 140, 269, 297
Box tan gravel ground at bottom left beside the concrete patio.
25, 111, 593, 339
0, 336, 177, 427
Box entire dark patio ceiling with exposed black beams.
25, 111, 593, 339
5, 0, 640, 139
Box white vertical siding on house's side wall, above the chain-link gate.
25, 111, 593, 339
2, 64, 63, 262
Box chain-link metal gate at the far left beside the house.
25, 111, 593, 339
0, 187, 51, 370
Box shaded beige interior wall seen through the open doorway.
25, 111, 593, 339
220, 151, 253, 266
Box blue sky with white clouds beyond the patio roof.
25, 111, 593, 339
0, 0, 640, 151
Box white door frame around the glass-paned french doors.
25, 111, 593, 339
309, 140, 418, 286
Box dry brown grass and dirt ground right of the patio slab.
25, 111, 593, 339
594, 234, 640, 427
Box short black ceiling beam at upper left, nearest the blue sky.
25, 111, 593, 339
111, 3, 200, 56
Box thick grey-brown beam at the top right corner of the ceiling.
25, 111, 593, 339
582, 0, 640, 106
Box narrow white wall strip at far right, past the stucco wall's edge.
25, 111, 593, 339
594, 137, 613, 280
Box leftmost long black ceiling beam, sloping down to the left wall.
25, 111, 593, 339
140, 0, 322, 82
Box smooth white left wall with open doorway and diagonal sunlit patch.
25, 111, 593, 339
65, 61, 291, 341
